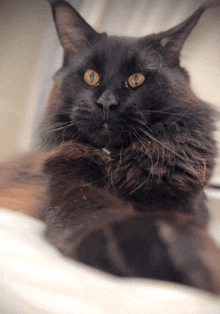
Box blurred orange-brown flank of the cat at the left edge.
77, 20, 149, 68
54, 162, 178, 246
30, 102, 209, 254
0, 150, 47, 219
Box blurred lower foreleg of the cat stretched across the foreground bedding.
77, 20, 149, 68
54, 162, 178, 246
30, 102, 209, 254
76, 215, 220, 294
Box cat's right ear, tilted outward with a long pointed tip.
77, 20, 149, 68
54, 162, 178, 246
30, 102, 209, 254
159, 0, 220, 62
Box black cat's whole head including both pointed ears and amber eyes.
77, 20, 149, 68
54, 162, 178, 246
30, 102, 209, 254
42, 0, 218, 149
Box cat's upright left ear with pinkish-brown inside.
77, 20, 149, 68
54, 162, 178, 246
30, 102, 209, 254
48, 0, 100, 61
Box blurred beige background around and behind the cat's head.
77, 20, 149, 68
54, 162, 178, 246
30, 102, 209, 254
0, 0, 220, 212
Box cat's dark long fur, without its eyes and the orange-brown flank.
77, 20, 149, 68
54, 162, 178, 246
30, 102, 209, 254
0, 0, 220, 294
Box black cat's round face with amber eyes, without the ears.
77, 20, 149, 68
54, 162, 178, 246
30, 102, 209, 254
54, 36, 185, 148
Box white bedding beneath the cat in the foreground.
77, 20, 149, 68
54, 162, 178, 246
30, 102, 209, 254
0, 208, 220, 314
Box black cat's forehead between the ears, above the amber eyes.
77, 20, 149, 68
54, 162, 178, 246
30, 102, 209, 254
71, 35, 161, 71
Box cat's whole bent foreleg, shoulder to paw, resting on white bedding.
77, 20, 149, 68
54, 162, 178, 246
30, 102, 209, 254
44, 142, 220, 293
